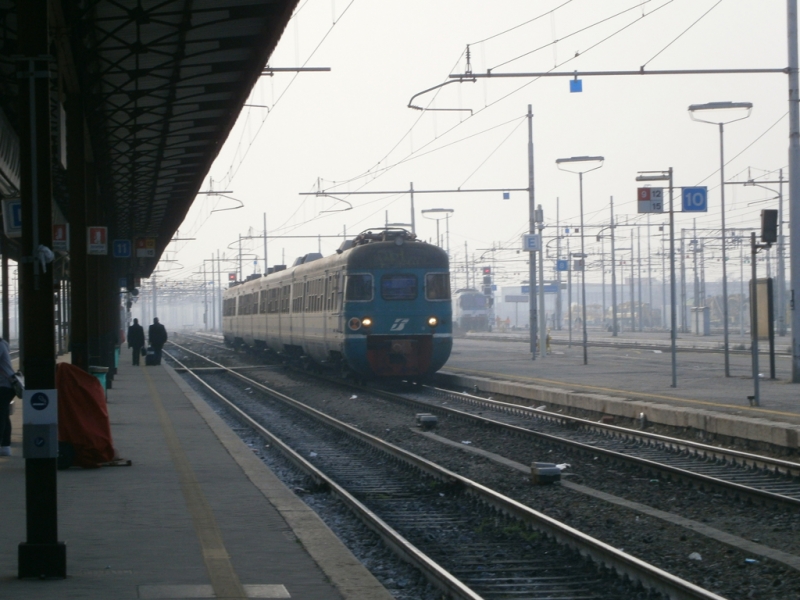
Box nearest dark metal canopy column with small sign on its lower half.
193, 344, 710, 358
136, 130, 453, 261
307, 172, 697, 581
16, 0, 67, 578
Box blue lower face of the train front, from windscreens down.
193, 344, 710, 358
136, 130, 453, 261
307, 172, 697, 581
344, 269, 453, 379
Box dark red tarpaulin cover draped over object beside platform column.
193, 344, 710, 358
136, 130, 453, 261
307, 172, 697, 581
56, 363, 117, 469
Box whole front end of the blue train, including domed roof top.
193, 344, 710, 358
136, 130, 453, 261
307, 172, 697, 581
343, 232, 453, 380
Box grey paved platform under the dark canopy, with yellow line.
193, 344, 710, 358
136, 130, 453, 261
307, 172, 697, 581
0, 354, 391, 600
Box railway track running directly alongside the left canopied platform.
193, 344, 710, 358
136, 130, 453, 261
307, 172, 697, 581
167, 346, 720, 599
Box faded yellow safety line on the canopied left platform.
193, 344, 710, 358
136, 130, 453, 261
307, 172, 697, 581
142, 369, 247, 599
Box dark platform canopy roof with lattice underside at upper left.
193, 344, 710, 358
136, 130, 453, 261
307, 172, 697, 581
0, 0, 298, 276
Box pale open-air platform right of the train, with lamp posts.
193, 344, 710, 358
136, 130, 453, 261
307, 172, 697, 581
439, 331, 800, 453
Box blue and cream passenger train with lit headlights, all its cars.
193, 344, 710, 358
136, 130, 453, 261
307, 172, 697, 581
222, 228, 453, 381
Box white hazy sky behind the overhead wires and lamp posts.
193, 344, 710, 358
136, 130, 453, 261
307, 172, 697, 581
160, 0, 788, 284
